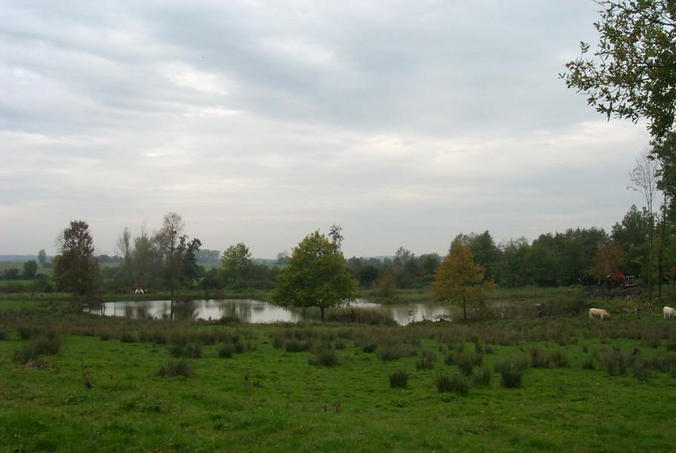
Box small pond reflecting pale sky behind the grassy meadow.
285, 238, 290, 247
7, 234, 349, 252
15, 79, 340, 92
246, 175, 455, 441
85, 299, 451, 325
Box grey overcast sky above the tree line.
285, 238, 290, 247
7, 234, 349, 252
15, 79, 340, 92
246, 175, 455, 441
0, 0, 649, 257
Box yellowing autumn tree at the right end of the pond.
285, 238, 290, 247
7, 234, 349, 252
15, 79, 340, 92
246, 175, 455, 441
432, 238, 492, 321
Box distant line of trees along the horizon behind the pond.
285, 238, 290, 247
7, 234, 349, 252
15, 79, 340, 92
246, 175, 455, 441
0, 200, 676, 298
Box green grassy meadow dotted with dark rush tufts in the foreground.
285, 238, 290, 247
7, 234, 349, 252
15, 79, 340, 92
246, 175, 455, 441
0, 299, 676, 452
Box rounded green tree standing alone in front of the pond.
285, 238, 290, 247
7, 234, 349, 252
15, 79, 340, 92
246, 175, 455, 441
272, 231, 358, 320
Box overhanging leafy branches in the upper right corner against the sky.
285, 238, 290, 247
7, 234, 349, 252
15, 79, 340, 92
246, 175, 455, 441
562, 0, 676, 139
